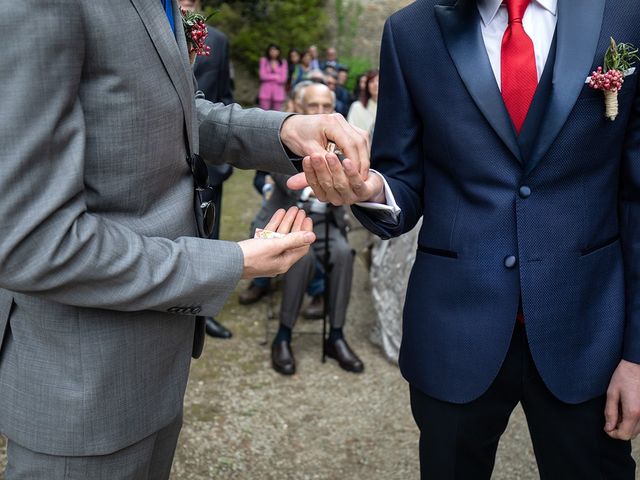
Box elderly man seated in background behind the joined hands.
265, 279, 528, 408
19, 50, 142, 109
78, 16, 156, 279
261, 83, 364, 375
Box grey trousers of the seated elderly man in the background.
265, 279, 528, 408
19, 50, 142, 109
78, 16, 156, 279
280, 214, 355, 328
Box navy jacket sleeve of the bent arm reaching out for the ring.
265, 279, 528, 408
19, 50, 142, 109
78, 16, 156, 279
352, 17, 424, 238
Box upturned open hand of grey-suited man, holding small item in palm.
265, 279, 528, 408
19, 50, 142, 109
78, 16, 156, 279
239, 207, 316, 279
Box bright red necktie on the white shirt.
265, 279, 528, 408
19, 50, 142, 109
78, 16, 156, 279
500, 0, 538, 134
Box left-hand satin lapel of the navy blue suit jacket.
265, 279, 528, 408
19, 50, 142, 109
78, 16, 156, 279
435, 0, 522, 163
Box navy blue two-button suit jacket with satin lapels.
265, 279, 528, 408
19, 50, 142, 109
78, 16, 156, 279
354, 0, 640, 403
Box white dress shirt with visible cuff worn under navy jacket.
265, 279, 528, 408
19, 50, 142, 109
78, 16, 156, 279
357, 0, 558, 222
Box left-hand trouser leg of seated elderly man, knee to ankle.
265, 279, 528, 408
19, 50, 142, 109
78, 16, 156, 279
280, 250, 315, 328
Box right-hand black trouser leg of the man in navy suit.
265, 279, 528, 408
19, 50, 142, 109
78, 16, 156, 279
522, 350, 635, 480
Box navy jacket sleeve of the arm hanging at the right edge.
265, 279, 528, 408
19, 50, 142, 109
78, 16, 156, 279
620, 77, 640, 364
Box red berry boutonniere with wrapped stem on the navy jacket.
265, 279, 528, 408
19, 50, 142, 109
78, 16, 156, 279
587, 38, 640, 121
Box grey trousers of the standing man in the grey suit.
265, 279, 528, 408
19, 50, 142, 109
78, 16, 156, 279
5, 414, 182, 480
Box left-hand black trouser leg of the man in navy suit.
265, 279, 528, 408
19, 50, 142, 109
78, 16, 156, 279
411, 327, 525, 480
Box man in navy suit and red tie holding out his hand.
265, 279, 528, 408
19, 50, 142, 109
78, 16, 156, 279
289, 0, 640, 474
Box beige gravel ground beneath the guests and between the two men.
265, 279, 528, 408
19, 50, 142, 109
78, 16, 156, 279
0, 171, 640, 480
